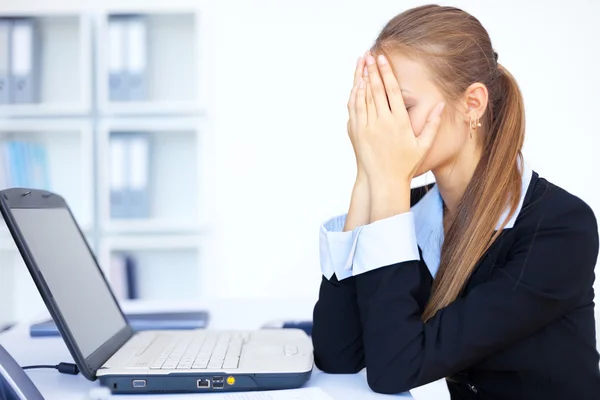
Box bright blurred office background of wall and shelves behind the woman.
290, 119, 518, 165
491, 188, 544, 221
0, 0, 600, 340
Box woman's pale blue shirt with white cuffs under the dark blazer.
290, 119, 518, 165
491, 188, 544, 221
319, 163, 533, 280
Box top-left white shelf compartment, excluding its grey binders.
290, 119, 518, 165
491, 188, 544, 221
0, 13, 91, 116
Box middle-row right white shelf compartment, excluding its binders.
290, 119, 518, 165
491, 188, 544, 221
97, 118, 203, 233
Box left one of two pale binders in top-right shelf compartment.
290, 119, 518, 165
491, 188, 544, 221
108, 16, 128, 101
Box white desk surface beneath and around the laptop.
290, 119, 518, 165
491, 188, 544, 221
0, 299, 411, 400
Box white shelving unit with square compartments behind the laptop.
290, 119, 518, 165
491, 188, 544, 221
0, 6, 211, 325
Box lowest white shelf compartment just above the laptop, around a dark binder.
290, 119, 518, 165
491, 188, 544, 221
100, 236, 202, 301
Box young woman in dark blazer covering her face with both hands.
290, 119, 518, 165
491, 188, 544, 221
313, 5, 600, 400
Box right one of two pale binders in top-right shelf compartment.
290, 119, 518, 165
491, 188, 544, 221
125, 16, 148, 101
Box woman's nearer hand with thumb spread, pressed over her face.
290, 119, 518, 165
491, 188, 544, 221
355, 54, 445, 189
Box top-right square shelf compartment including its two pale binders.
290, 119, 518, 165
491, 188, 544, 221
97, 12, 202, 115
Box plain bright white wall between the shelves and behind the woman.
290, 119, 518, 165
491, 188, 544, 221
0, 0, 600, 304
